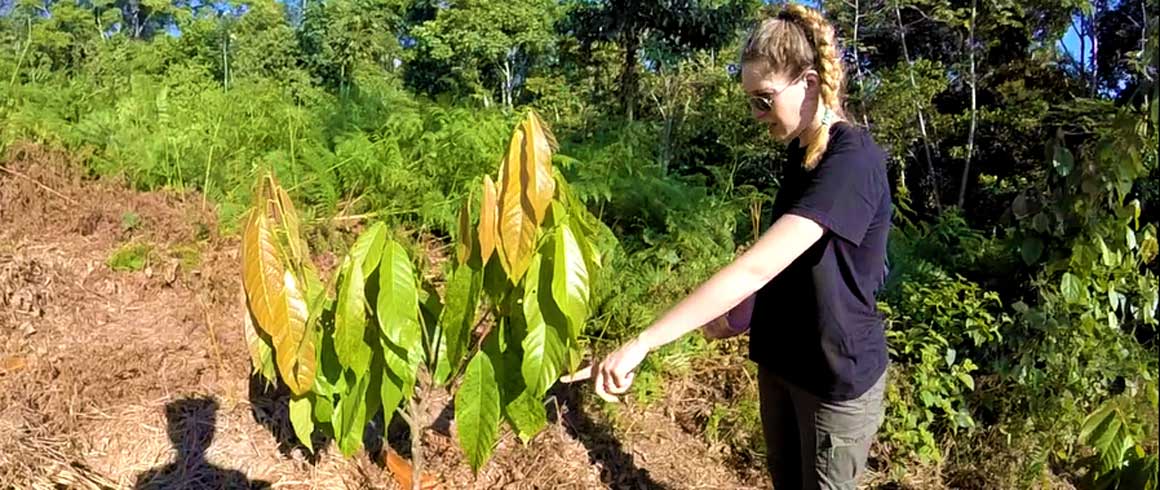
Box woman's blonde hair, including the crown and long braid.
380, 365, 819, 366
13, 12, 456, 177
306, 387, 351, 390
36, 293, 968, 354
741, 3, 846, 170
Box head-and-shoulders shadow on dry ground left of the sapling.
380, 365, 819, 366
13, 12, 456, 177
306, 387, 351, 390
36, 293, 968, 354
133, 397, 270, 490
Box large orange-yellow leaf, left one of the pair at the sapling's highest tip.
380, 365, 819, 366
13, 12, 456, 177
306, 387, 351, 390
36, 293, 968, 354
499, 120, 538, 282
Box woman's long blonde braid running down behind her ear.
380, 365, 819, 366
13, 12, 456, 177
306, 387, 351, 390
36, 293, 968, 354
783, 3, 846, 168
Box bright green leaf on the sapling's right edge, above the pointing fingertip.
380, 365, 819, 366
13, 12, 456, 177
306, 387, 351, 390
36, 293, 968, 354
552, 221, 589, 340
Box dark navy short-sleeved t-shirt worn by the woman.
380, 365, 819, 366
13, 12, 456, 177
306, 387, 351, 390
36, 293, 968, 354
749, 123, 891, 401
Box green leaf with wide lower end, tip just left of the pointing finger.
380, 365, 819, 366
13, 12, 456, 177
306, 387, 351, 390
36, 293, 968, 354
516, 253, 567, 396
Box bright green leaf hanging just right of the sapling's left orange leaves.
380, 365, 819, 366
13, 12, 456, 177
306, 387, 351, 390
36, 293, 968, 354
334, 255, 372, 373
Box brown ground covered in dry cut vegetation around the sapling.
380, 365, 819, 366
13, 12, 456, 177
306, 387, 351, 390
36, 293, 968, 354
0, 145, 768, 489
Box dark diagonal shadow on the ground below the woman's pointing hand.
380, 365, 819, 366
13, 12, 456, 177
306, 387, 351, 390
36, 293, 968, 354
549, 383, 668, 490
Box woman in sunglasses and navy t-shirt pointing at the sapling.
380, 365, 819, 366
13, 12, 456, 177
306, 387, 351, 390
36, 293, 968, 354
564, 5, 891, 489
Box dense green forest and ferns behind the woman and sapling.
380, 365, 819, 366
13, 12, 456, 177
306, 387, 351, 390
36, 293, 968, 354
0, 0, 1160, 489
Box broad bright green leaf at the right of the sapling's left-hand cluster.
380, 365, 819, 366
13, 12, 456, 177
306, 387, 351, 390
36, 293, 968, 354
376, 240, 426, 363
